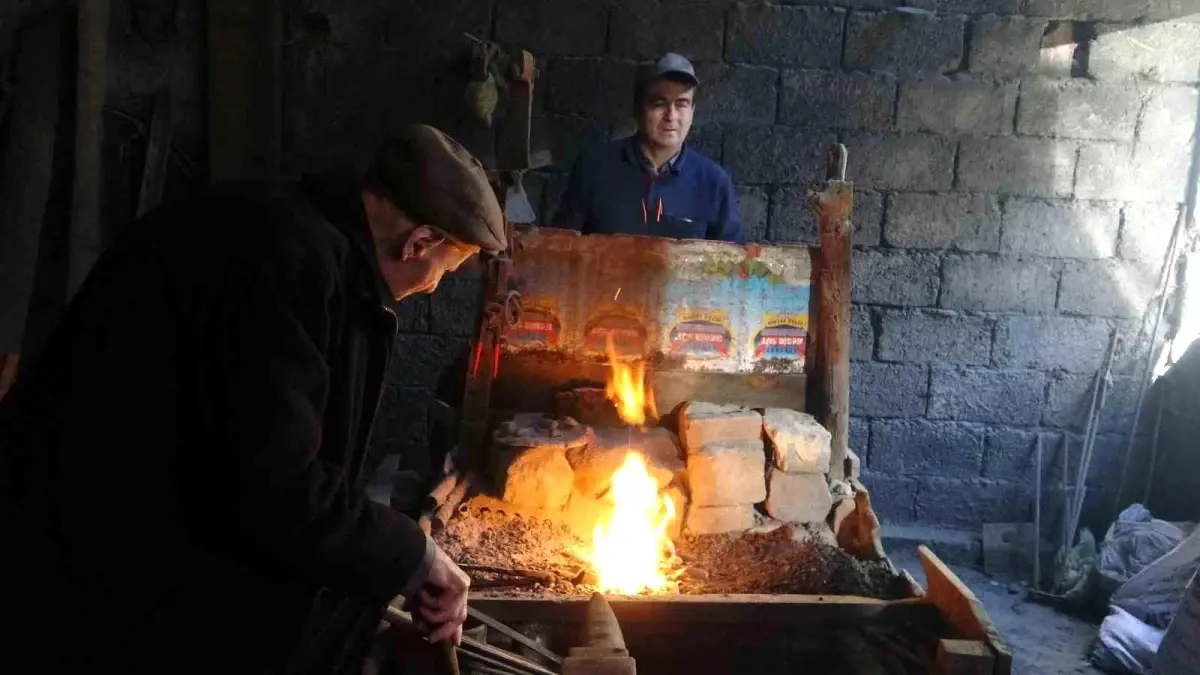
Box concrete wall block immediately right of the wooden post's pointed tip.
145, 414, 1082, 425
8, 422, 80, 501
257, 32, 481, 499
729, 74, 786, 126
846, 133, 954, 191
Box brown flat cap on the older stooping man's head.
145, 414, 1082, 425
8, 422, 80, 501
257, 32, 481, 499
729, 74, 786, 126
367, 125, 506, 252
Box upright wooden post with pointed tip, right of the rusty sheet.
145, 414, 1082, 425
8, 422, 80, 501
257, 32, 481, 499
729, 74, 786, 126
809, 144, 854, 480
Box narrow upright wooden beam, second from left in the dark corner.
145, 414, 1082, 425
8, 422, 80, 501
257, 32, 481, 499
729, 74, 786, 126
67, 0, 110, 300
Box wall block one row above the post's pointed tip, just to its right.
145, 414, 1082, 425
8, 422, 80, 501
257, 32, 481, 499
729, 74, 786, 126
896, 77, 1016, 136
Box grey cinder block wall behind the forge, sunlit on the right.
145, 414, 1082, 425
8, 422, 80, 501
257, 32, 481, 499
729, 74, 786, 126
7, 0, 1200, 531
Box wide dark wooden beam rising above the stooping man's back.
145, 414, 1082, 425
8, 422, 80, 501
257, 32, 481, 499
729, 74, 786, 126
206, 0, 283, 181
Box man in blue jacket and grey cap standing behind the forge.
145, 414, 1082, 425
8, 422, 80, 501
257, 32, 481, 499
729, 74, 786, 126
553, 54, 745, 244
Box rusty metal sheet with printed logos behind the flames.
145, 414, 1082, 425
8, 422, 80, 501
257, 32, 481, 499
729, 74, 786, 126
506, 228, 812, 374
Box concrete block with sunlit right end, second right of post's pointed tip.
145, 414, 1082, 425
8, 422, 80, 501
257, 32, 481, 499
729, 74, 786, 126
956, 138, 1078, 197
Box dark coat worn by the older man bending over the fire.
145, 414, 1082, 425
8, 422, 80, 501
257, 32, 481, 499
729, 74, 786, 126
0, 169, 433, 674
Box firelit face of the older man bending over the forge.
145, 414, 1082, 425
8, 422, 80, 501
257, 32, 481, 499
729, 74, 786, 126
362, 191, 479, 300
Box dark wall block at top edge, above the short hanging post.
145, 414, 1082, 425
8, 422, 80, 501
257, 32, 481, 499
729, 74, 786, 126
496, 0, 608, 58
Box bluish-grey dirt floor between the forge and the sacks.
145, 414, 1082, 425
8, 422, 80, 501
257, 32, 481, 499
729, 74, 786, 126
888, 550, 1102, 675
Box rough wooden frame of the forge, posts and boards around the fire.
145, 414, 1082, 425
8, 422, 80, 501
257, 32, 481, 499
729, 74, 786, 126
426, 145, 1012, 675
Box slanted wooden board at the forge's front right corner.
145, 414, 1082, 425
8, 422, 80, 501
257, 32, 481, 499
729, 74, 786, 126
917, 545, 1013, 675
